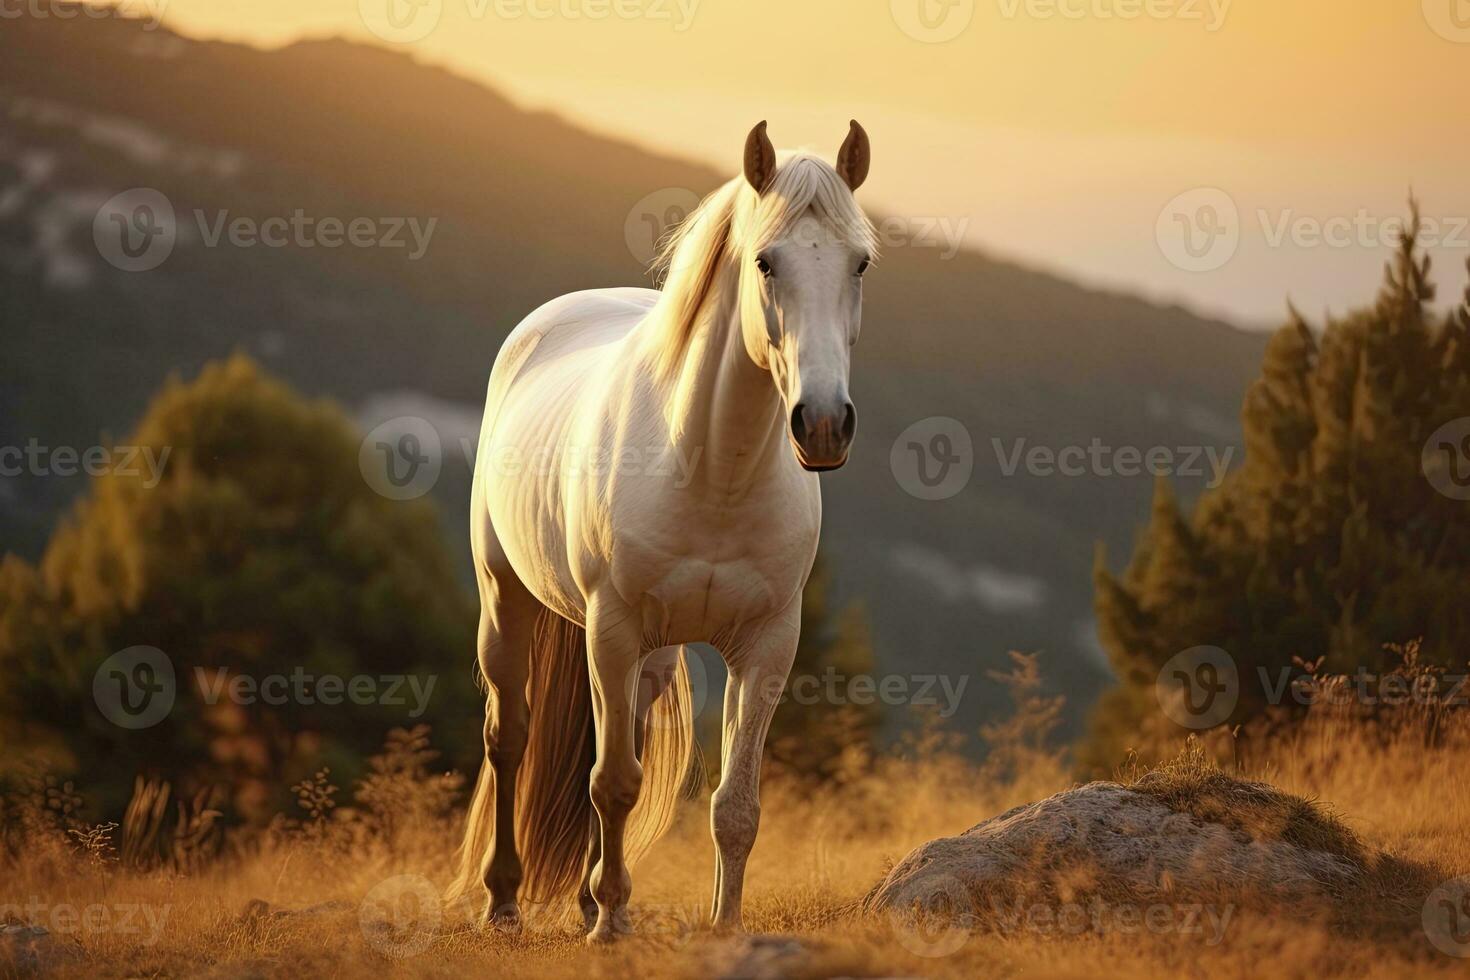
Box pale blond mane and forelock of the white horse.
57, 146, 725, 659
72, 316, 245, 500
650, 150, 878, 375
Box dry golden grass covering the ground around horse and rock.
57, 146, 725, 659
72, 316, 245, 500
0, 702, 1470, 980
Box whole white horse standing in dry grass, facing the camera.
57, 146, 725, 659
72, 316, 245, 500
450, 120, 876, 942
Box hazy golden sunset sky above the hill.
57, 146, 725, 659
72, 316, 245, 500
129, 0, 1470, 320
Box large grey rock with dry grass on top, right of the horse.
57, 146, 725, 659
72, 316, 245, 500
864, 767, 1364, 942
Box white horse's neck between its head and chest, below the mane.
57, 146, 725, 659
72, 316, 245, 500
669, 276, 785, 495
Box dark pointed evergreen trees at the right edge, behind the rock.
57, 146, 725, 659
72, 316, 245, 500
1089, 209, 1470, 765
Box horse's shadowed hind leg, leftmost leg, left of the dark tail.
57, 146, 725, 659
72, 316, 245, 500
476, 552, 541, 929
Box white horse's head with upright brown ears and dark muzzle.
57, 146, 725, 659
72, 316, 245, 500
738, 120, 876, 470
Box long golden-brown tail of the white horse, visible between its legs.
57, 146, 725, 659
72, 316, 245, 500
447, 610, 695, 902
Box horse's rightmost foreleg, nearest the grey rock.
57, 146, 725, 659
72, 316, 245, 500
710, 608, 801, 929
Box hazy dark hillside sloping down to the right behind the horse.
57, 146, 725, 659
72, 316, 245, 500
0, 11, 1264, 740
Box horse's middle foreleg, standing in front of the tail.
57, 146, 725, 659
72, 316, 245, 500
587, 599, 642, 943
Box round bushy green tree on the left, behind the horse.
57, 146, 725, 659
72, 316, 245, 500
0, 357, 481, 817
